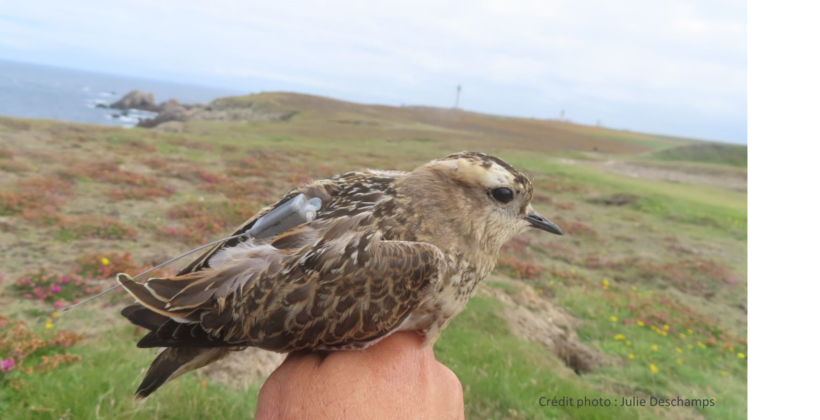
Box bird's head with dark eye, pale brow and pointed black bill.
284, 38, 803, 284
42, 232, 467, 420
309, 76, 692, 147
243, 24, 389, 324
410, 152, 563, 253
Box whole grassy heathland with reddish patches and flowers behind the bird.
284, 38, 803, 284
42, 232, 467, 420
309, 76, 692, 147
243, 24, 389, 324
0, 93, 750, 419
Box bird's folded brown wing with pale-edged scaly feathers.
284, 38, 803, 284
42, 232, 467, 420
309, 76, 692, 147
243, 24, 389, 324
120, 213, 447, 352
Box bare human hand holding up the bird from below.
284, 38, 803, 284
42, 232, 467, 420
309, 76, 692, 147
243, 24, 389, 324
256, 333, 464, 420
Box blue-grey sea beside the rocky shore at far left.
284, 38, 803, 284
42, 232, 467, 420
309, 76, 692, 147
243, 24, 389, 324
0, 60, 243, 127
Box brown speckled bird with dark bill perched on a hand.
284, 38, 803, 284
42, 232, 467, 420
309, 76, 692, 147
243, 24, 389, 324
117, 152, 563, 399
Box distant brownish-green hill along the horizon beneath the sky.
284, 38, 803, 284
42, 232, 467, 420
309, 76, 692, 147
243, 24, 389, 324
176, 93, 692, 154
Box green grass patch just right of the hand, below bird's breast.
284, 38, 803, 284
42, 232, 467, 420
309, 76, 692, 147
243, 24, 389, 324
436, 297, 646, 420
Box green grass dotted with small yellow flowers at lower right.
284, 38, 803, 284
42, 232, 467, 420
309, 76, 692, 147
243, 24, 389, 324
557, 288, 750, 419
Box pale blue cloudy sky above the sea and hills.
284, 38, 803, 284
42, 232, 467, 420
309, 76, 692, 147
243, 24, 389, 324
0, 0, 750, 144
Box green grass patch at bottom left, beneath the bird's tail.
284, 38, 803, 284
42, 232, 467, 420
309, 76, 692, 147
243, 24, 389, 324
0, 327, 261, 420
